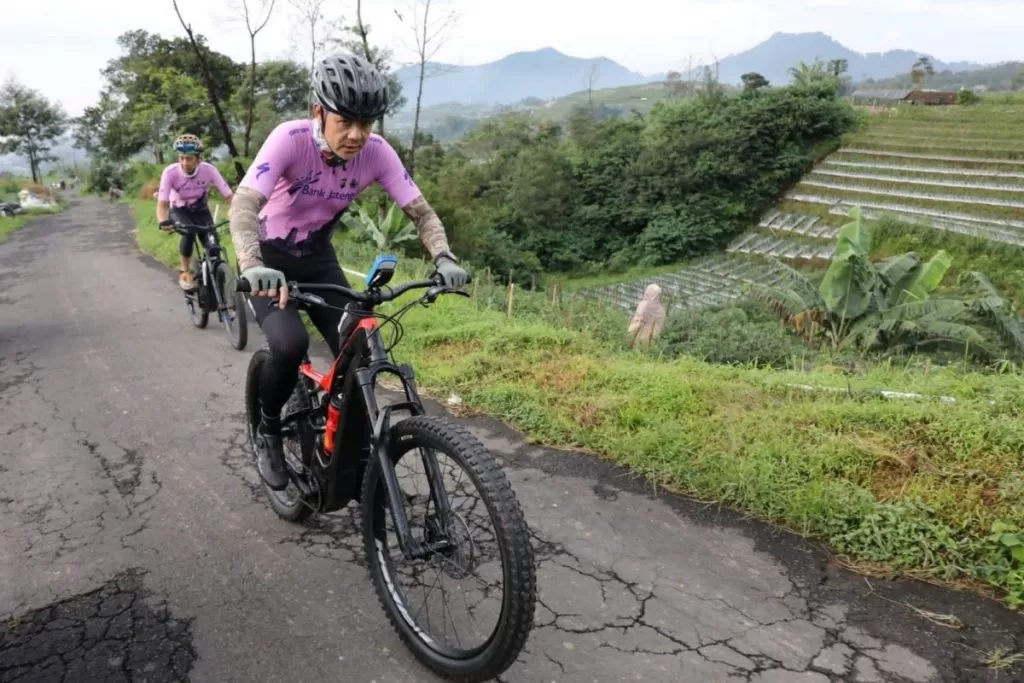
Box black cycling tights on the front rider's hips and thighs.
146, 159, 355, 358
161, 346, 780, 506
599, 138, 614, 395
250, 247, 349, 416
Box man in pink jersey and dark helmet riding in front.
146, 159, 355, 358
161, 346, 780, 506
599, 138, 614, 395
230, 52, 468, 490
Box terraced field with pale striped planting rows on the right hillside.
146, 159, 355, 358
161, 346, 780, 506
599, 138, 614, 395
580, 101, 1024, 312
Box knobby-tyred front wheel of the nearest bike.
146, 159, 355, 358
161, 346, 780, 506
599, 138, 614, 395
361, 416, 537, 683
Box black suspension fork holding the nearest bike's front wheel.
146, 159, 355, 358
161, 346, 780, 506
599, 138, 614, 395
355, 361, 451, 560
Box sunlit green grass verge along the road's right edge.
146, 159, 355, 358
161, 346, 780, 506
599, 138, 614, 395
128, 196, 1024, 608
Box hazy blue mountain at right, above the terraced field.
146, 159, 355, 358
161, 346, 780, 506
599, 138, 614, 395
719, 33, 982, 85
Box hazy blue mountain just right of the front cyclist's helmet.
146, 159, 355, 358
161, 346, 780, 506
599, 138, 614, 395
395, 47, 652, 109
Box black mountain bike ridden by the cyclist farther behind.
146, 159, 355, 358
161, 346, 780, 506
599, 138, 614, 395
171, 220, 249, 351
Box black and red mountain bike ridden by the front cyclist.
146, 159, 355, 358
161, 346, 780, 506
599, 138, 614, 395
238, 257, 537, 682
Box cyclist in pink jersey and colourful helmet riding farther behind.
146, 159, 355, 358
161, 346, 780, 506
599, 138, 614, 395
157, 133, 233, 291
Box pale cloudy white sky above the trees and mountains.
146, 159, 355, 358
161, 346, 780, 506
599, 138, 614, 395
0, 0, 1024, 116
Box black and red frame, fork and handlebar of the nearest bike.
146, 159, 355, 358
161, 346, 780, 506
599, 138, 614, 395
238, 278, 468, 559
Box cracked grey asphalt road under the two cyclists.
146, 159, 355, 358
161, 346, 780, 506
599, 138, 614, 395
0, 194, 1024, 683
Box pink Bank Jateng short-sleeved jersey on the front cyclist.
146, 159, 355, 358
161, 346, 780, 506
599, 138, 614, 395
239, 119, 420, 255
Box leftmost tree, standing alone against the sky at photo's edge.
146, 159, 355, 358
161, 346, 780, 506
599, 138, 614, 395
0, 78, 68, 182
